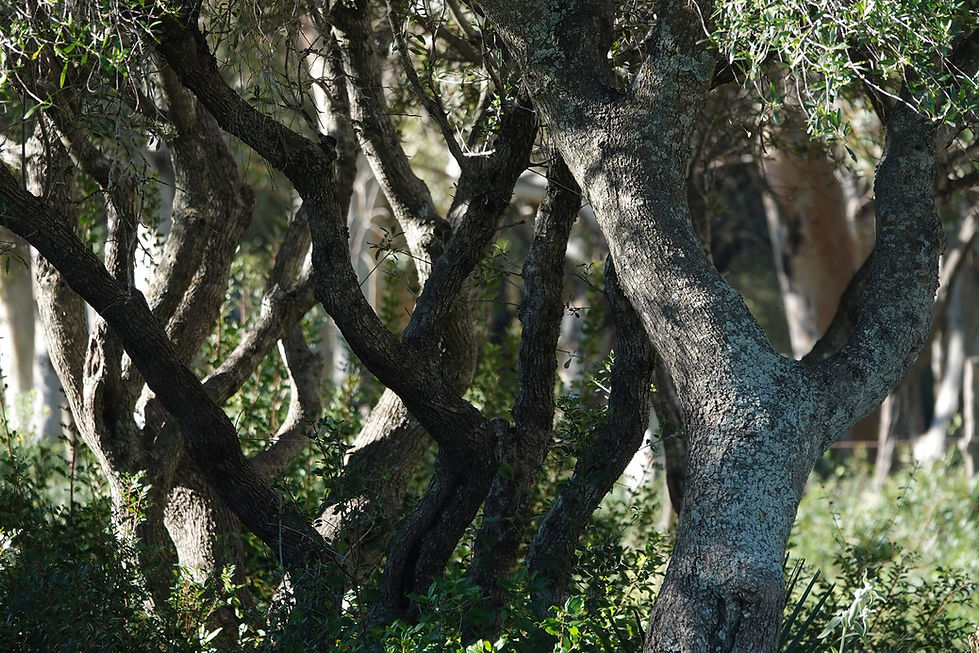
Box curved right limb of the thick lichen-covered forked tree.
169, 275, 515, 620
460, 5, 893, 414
817, 104, 944, 437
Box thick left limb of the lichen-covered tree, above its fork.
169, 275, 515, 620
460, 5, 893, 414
479, 0, 777, 402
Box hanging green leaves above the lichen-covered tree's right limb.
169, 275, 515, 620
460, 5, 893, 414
713, 0, 979, 134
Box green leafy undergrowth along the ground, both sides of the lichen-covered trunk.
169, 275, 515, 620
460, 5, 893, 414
7, 422, 979, 653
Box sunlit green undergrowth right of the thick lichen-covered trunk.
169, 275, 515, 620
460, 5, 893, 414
783, 454, 979, 652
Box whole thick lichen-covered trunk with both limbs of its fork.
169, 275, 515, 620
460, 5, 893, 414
470, 0, 960, 651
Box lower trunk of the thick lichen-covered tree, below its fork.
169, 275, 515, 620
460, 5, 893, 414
643, 376, 819, 653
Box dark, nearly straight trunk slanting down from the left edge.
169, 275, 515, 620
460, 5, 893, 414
0, 167, 326, 569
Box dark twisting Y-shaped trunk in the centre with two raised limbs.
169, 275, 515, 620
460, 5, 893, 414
156, 8, 536, 619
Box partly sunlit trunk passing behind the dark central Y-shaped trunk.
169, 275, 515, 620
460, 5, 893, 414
314, 3, 476, 580
